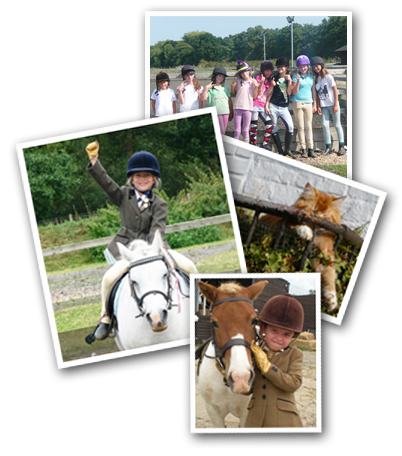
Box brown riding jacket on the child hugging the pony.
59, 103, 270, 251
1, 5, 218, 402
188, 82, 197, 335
245, 347, 303, 428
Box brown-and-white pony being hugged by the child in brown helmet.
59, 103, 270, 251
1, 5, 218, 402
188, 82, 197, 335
198, 280, 268, 428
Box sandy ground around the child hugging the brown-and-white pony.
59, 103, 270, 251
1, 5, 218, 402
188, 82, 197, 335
195, 350, 317, 428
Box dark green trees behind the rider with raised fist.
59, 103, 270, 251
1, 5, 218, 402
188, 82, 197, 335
24, 115, 221, 221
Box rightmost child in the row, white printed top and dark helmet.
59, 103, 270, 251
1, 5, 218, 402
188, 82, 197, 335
311, 56, 346, 155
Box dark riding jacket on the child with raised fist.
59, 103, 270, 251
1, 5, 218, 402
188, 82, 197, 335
87, 159, 169, 260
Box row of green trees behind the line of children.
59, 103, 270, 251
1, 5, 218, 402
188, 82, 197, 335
150, 16, 347, 68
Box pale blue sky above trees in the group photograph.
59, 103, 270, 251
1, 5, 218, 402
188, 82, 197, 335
150, 13, 328, 46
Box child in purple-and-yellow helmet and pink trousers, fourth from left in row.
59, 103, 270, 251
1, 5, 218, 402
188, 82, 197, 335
231, 60, 258, 143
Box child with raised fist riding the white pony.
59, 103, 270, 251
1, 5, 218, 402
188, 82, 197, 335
86, 141, 169, 339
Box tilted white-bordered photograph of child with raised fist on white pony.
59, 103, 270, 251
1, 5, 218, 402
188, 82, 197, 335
17, 109, 245, 368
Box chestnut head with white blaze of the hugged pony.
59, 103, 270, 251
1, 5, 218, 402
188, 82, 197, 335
198, 280, 268, 394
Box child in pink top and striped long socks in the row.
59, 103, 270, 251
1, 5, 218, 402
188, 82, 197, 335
250, 60, 274, 150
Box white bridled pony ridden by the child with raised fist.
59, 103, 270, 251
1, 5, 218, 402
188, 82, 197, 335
114, 231, 197, 350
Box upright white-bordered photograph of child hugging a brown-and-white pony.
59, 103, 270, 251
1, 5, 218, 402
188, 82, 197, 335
190, 273, 322, 433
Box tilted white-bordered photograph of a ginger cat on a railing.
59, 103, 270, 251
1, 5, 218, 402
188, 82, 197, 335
223, 137, 386, 324
